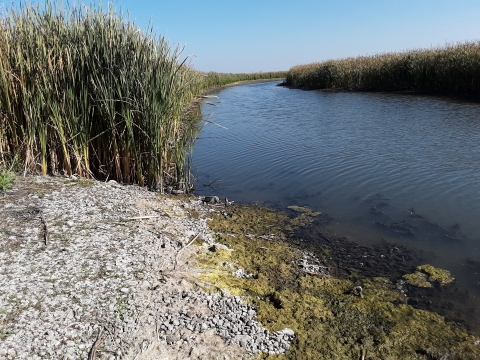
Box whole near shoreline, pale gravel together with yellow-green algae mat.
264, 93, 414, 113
0, 176, 480, 360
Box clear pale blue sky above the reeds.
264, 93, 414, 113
0, 0, 480, 72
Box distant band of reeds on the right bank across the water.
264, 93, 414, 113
286, 42, 480, 93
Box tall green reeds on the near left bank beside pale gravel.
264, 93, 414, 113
0, 2, 285, 190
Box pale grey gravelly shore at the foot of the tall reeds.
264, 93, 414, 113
0, 177, 295, 359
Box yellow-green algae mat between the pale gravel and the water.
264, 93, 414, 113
198, 206, 480, 360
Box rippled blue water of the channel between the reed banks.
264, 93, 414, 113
194, 83, 480, 330
